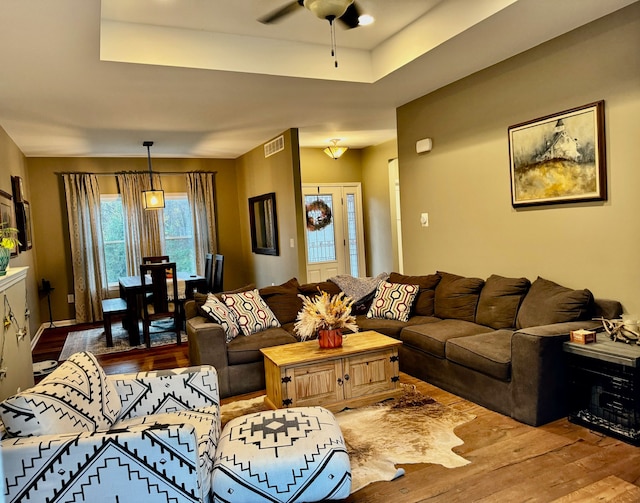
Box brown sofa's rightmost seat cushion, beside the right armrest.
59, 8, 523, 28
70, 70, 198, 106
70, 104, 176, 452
446, 330, 513, 381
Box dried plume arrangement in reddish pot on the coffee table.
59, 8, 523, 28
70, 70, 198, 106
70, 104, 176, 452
294, 292, 358, 348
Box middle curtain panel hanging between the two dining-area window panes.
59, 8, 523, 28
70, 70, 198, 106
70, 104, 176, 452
116, 172, 164, 275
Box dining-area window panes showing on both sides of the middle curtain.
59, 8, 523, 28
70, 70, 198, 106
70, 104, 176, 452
100, 193, 196, 285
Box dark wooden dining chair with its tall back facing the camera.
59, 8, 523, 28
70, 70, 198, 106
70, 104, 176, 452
140, 262, 182, 348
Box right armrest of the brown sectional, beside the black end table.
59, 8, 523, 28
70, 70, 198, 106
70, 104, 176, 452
511, 321, 601, 426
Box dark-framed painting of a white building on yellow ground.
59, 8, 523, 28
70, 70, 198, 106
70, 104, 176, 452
508, 101, 607, 207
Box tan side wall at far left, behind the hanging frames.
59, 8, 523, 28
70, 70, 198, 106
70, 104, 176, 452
0, 127, 40, 336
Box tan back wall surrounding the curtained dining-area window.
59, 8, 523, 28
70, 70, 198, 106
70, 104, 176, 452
27, 158, 244, 320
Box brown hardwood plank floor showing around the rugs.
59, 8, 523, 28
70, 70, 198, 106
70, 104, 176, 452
33, 327, 640, 503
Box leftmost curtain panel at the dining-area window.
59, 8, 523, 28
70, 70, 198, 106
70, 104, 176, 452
62, 173, 108, 323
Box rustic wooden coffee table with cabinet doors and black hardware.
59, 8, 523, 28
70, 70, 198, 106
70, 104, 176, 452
261, 331, 402, 412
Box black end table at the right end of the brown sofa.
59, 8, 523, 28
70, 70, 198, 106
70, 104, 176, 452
564, 334, 640, 445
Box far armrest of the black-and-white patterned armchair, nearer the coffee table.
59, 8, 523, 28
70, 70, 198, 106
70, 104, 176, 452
107, 365, 220, 420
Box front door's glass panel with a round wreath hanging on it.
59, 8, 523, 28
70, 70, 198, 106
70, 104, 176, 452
304, 194, 336, 264
